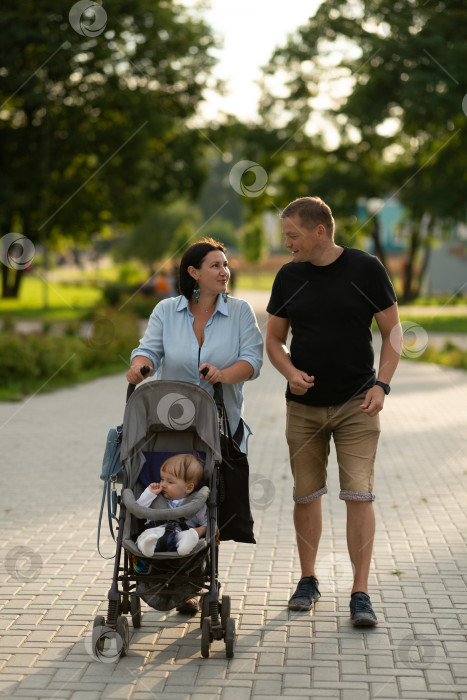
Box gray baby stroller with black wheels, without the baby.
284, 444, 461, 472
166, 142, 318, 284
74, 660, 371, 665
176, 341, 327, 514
92, 372, 235, 658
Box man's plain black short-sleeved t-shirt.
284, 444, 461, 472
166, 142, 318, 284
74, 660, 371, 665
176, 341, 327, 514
267, 248, 396, 406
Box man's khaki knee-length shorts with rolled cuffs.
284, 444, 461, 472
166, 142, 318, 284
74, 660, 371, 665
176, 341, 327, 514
285, 392, 380, 503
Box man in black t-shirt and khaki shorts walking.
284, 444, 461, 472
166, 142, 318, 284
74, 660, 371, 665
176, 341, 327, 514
266, 197, 401, 625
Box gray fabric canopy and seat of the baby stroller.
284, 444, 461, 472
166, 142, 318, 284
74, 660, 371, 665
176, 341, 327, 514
116, 380, 222, 610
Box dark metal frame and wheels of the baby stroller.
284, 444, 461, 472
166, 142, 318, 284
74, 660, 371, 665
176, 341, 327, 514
92, 368, 236, 659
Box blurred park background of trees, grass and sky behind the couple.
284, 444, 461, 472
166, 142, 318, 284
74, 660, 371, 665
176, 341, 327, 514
0, 0, 467, 400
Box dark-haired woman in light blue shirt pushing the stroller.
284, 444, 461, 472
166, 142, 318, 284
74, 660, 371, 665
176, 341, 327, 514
126, 238, 263, 460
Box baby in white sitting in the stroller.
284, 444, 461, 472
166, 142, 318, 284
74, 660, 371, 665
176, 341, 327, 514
136, 454, 208, 557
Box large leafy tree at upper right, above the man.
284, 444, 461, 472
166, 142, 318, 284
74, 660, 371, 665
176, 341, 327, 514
263, 0, 467, 298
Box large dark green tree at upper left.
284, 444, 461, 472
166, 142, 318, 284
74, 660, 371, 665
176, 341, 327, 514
0, 0, 218, 295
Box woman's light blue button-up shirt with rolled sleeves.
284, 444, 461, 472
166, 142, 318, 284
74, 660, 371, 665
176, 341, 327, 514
131, 295, 263, 451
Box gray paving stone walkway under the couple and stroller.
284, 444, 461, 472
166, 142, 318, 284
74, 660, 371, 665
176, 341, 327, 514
0, 296, 467, 700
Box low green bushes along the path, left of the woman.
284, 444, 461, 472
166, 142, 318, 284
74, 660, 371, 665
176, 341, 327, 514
0, 309, 139, 399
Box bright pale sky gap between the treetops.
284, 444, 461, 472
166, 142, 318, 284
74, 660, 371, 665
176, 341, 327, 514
193, 0, 321, 120
